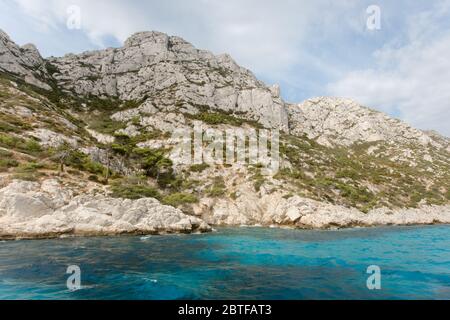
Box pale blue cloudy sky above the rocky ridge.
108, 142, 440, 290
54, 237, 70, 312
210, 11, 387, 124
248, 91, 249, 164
0, 0, 450, 136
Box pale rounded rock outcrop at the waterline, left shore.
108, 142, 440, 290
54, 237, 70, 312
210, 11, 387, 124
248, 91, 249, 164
0, 180, 211, 239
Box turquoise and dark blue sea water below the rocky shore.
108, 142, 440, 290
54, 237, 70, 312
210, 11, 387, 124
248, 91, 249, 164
0, 226, 450, 299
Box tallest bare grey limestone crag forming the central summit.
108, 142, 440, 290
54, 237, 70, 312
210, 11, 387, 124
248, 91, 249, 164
50, 32, 288, 131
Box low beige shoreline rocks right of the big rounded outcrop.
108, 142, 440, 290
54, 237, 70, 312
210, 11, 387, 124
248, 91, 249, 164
199, 182, 450, 229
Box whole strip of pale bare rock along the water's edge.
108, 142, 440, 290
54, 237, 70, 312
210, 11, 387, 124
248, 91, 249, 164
0, 179, 450, 240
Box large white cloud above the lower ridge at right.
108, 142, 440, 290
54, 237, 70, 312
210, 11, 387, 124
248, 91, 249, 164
327, 1, 450, 136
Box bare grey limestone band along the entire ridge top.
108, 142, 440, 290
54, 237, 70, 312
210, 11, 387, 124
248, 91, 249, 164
0, 31, 449, 146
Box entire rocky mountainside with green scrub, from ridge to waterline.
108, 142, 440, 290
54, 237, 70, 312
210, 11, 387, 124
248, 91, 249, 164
0, 32, 450, 236
